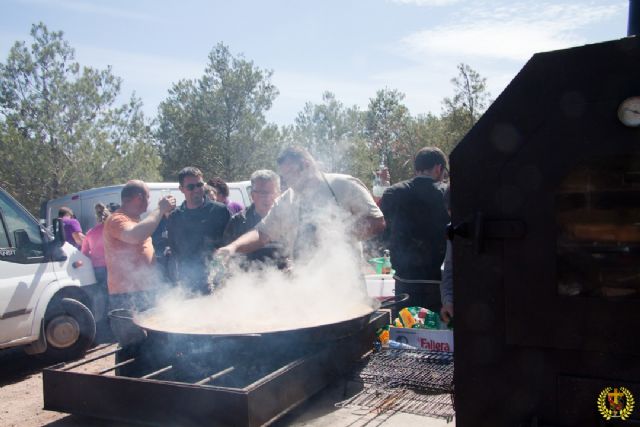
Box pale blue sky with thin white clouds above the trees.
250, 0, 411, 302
0, 0, 628, 125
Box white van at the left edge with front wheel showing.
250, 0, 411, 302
0, 188, 97, 360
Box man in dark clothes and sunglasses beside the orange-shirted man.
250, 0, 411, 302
167, 166, 231, 294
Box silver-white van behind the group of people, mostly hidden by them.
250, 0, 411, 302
41, 181, 251, 233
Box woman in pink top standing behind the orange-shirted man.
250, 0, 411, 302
82, 203, 109, 320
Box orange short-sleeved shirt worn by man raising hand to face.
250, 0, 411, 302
103, 211, 158, 294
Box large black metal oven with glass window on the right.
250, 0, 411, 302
451, 31, 640, 427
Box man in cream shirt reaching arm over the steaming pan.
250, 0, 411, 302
218, 147, 385, 259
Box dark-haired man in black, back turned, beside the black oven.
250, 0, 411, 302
380, 147, 449, 313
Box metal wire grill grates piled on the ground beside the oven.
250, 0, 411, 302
336, 349, 455, 422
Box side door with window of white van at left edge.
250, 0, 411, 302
0, 191, 56, 347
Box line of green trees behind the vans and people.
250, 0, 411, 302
0, 23, 491, 214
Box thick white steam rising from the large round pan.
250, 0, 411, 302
145, 203, 373, 334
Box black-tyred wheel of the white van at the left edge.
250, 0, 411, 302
44, 298, 96, 361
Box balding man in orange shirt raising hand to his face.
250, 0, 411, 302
103, 180, 176, 310
